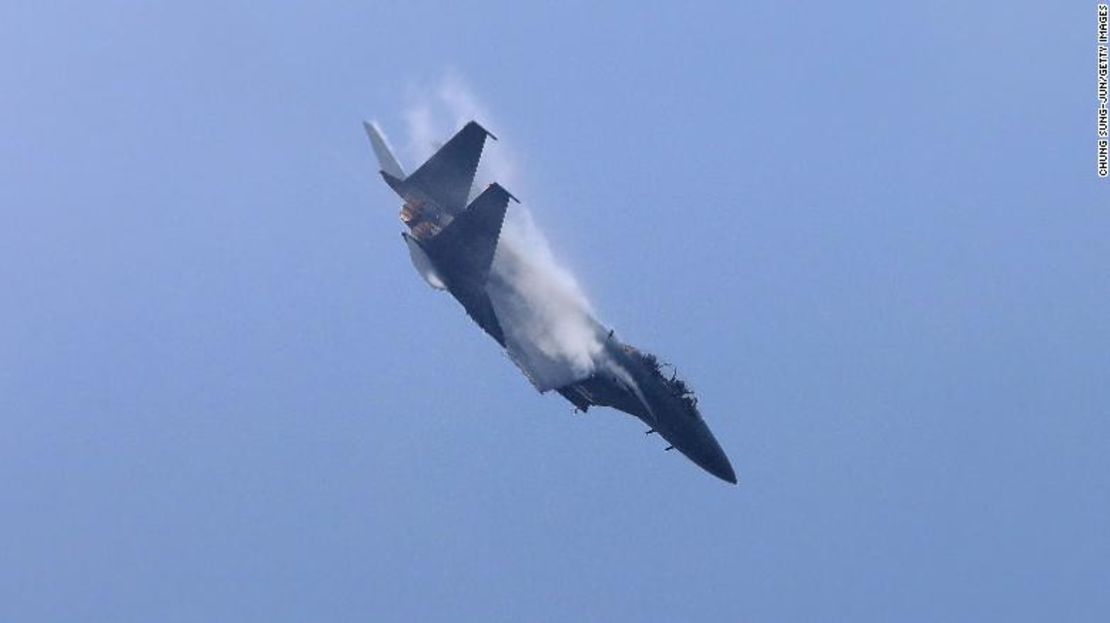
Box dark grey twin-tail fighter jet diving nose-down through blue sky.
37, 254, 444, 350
364, 121, 736, 484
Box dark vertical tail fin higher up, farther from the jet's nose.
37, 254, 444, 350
405, 121, 493, 214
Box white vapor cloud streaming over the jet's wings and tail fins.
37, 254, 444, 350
405, 77, 605, 391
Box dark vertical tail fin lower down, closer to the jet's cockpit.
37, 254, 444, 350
426, 182, 515, 283
